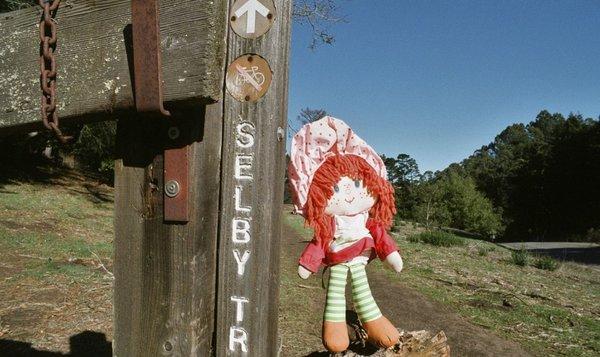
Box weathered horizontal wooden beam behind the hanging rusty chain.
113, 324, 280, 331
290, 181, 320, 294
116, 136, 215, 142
0, 0, 227, 132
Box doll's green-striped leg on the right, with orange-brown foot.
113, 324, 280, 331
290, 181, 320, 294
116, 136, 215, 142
350, 263, 400, 348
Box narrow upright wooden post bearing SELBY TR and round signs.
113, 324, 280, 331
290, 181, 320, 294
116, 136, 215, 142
215, 0, 291, 356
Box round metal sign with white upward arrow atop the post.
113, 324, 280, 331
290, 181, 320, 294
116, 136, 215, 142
229, 0, 276, 38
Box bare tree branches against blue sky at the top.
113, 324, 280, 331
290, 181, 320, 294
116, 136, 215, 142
292, 0, 346, 50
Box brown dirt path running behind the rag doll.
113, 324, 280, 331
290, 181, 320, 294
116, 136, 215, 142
281, 218, 530, 357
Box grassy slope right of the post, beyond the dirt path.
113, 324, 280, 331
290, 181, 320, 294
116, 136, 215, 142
281, 215, 600, 356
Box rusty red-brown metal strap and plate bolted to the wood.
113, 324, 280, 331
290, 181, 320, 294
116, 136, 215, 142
131, 0, 189, 222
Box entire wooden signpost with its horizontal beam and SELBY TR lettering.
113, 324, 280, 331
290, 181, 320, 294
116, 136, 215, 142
0, 0, 291, 357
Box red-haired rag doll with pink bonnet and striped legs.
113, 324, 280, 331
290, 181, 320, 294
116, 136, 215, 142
288, 117, 403, 352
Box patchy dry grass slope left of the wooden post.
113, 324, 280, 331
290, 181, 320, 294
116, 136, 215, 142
0, 173, 113, 351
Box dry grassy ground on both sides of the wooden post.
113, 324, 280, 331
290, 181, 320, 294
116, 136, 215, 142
0, 175, 600, 355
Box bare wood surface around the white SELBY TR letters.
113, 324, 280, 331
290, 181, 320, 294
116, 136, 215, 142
214, 0, 292, 356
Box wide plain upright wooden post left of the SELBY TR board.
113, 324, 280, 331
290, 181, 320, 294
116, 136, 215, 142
113, 103, 223, 357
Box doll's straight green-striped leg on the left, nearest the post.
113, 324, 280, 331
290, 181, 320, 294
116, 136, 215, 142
323, 264, 350, 352
